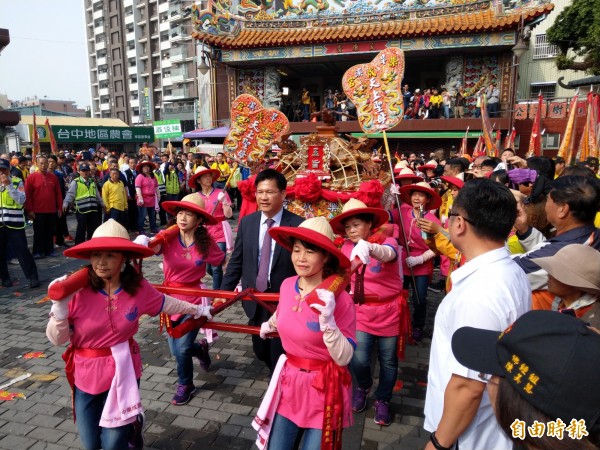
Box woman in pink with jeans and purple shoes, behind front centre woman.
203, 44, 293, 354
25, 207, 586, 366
330, 199, 402, 426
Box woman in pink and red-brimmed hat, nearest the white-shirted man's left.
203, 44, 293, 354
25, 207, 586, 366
392, 182, 442, 343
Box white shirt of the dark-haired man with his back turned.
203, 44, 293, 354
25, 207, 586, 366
425, 247, 531, 450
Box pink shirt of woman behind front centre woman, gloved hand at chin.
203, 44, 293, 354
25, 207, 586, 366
342, 237, 402, 336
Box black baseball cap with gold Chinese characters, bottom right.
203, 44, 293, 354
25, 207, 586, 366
452, 311, 600, 429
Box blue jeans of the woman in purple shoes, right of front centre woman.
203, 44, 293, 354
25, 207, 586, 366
350, 330, 398, 402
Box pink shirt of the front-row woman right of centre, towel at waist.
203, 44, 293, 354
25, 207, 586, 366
277, 276, 356, 429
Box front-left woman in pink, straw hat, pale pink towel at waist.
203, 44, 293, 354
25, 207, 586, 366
46, 219, 210, 450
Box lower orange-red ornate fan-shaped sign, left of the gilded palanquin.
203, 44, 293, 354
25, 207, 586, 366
223, 94, 289, 164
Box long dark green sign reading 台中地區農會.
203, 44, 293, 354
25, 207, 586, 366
47, 125, 154, 143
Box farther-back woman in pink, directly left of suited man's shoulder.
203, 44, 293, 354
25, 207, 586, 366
189, 166, 233, 289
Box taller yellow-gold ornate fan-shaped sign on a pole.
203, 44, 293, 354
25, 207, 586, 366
342, 48, 404, 133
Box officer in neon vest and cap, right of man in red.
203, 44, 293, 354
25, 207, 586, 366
63, 163, 102, 244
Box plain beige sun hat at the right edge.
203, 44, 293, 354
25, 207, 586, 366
531, 244, 600, 295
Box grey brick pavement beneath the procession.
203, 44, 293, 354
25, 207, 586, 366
0, 216, 441, 450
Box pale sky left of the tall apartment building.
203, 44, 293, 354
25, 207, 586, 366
0, 0, 91, 108
